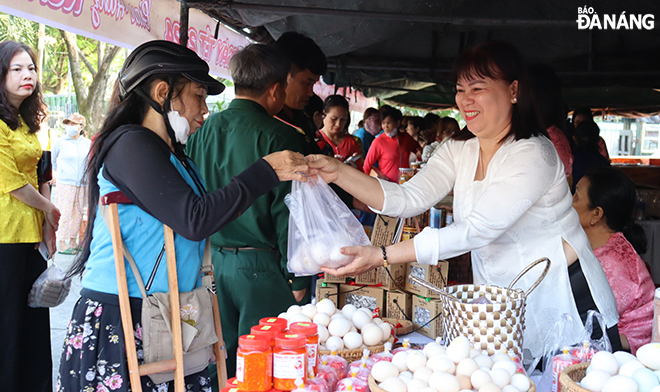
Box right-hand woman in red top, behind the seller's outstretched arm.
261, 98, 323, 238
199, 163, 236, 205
362, 105, 420, 182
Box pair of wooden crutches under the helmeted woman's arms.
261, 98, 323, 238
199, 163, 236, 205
107, 203, 227, 392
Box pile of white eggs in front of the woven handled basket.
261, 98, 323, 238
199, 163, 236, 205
371, 336, 531, 392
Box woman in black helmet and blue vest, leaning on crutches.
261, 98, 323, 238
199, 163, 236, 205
56, 41, 307, 391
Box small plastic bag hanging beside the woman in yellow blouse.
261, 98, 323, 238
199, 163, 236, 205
28, 263, 71, 308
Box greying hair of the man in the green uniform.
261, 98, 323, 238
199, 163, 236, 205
229, 44, 290, 96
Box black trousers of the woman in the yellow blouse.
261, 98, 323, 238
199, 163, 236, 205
0, 244, 53, 392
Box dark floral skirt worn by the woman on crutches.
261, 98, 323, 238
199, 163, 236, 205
55, 289, 211, 392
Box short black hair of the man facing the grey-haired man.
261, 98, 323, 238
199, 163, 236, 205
275, 31, 328, 75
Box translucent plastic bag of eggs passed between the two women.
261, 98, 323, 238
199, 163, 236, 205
284, 177, 371, 276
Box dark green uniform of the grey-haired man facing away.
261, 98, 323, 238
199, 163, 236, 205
186, 98, 310, 382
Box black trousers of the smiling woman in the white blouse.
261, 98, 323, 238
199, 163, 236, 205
568, 260, 623, 351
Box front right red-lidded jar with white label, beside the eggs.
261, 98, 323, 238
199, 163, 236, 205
273, 334, 307, 391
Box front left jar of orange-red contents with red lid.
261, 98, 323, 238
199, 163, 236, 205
236, 335, 273, 392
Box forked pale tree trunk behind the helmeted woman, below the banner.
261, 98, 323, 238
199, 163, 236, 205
60, 30, 120, 135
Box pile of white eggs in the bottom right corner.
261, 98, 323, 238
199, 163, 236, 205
580, 343, 660, 392
